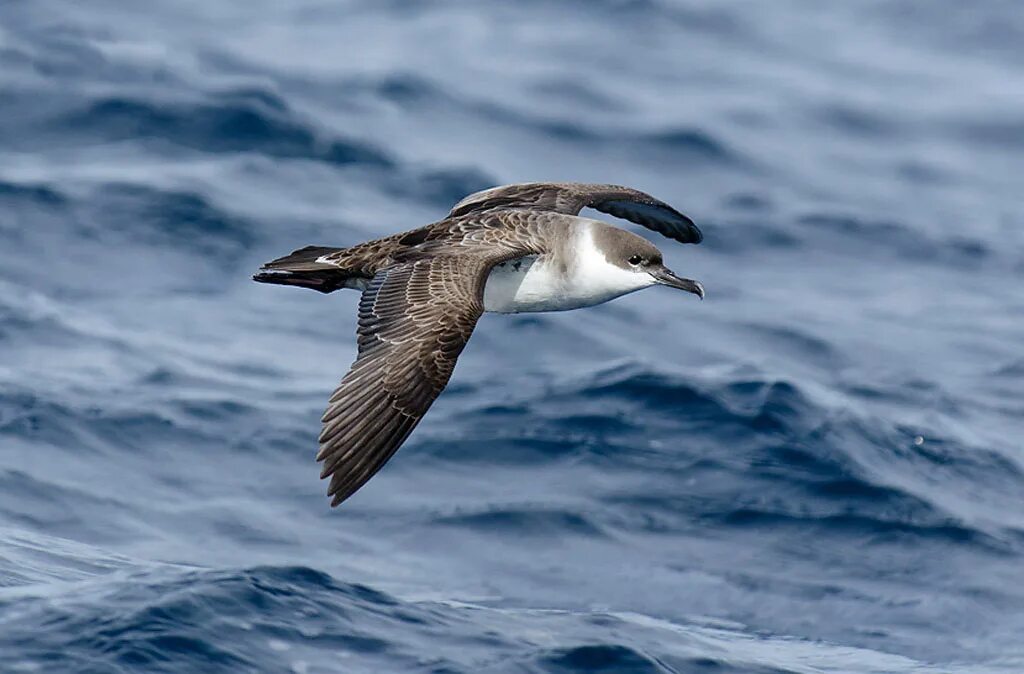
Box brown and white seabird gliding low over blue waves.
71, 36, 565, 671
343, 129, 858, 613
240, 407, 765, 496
253, 182, 705, 506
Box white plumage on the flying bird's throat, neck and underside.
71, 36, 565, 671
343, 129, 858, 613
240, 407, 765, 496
483, 222, 654, 313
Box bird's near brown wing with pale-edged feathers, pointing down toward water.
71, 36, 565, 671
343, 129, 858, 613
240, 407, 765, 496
316, 255, 491, 506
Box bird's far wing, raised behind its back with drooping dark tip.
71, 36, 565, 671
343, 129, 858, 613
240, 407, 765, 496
449, 182, 703, 244
